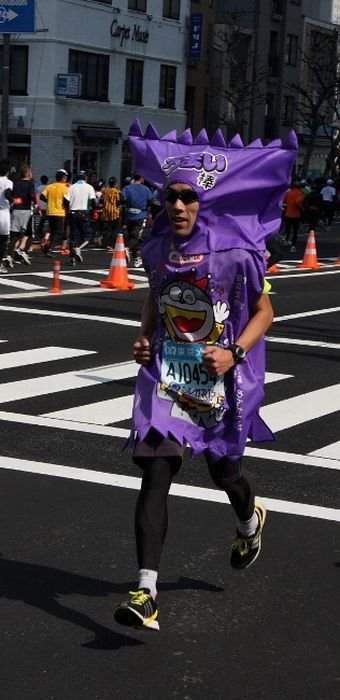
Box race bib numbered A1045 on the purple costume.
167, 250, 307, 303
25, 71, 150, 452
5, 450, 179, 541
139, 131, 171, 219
161, 340, 225, 408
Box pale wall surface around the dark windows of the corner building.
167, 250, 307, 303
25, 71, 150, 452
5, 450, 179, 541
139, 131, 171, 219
5, 0, 190, 183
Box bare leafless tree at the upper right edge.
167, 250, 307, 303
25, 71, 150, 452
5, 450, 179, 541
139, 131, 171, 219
287, 26, 340, 175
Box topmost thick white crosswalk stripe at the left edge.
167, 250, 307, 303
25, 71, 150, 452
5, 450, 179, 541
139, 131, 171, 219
0, 345, 97, 372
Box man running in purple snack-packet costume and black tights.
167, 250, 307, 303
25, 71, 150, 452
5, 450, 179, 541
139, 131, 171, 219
114, 119, 297, 630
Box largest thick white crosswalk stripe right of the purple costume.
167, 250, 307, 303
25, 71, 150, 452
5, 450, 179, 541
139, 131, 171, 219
260, 384, 340, 433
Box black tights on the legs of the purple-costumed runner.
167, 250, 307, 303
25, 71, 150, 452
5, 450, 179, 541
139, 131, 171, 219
135, 457, 255, 571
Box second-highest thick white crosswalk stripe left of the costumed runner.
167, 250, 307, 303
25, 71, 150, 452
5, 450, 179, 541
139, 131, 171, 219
0, 362, 139, 404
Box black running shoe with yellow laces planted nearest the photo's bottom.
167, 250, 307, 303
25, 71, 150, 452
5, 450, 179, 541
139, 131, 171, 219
114, 588, 159, 630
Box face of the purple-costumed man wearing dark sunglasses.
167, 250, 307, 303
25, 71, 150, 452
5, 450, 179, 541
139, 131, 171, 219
165, 182, 199, 236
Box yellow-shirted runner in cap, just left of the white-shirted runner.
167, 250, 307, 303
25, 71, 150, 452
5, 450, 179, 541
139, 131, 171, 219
39, 168, 68, 257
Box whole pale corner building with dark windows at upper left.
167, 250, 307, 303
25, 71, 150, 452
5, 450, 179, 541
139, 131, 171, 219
0, 0, 189, 179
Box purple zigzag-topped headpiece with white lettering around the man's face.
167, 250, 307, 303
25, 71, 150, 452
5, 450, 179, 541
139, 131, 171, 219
129, 120, 297, 250
